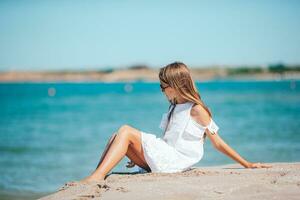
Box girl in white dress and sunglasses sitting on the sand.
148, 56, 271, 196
65, 62, 271, 188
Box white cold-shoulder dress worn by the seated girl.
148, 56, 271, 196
141, 102, 219, 173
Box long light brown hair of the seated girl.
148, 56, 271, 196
159, 62, 212, 139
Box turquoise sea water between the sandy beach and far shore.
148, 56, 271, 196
0, 80, 300, 196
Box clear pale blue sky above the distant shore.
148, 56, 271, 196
0, 0, 300, 70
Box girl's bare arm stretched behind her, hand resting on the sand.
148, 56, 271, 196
206, 129, 272, 168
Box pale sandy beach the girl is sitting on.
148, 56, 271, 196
40, 162, 300, 200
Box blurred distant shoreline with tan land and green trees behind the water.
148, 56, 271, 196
0, 66, 300, 83
